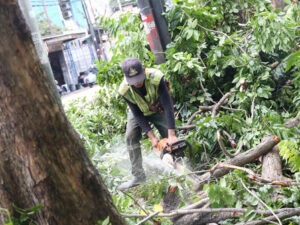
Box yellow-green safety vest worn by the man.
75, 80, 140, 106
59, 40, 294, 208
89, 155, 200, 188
119, 68, 164, 116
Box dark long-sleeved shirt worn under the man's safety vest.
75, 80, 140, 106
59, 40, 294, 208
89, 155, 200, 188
124, 78, 175, 133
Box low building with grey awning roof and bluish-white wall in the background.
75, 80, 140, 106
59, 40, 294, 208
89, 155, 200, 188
43, 32, 97, 91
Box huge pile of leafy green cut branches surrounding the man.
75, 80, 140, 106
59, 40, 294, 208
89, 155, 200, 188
69, 0, 300, 224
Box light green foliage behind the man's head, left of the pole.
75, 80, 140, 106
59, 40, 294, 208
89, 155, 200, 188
97, 12, 154, 84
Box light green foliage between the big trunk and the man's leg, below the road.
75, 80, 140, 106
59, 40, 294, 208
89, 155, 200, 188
66, 85, 126, 156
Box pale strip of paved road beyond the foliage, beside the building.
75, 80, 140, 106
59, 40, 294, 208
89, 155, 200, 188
61, 85, 100, 104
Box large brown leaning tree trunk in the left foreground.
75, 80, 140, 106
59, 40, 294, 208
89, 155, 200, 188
0, 0, 125, 225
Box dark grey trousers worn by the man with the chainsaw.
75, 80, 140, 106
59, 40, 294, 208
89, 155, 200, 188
126, 111, 168, 177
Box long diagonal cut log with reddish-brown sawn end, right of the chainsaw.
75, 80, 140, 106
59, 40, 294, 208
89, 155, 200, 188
193, 136, 280, 191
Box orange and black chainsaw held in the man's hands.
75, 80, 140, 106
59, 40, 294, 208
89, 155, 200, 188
157, 138, 192, 162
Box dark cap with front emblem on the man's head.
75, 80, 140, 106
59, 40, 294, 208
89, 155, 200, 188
122, 58, 146, 85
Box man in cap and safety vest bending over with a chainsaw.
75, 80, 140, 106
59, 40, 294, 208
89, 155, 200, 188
119, 58, 178, 190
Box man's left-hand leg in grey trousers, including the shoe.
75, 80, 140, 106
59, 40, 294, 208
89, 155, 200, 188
119, 112, 146, 190
